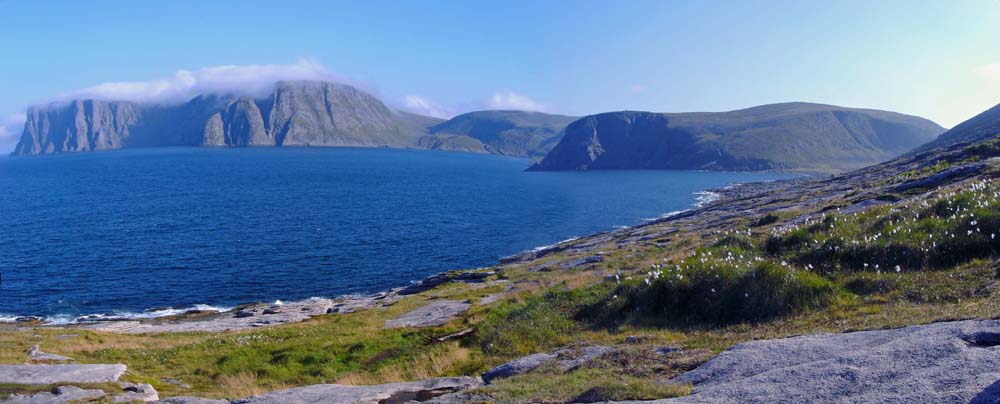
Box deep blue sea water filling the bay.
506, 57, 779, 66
0, 148, 779, 318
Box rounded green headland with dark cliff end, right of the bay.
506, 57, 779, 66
530, 103, 944, 171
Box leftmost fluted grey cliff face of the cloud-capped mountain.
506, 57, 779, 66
13, 100, 142, 155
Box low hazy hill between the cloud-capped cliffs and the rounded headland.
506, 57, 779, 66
420, 111, 577, 157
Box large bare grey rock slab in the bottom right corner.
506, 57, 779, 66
608, 320, 1000, 404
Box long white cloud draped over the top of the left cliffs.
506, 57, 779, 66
48, 59, 363, 103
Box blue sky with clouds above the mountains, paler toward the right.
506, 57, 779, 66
0, 0, 1000, 151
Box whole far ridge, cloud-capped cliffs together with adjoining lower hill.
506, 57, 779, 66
11, 81, 575, 157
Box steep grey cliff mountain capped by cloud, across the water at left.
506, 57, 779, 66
12, 81, 441, 156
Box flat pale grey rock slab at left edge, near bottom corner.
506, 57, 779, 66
0, 364, 126, 384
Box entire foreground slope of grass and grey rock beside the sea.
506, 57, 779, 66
0, 100, 1000, 403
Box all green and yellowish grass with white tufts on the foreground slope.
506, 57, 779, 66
0, 178, 1000, 403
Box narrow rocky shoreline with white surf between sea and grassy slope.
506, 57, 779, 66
0, 177, 788, 329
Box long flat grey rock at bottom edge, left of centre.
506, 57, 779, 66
233, 377, 482, 404
